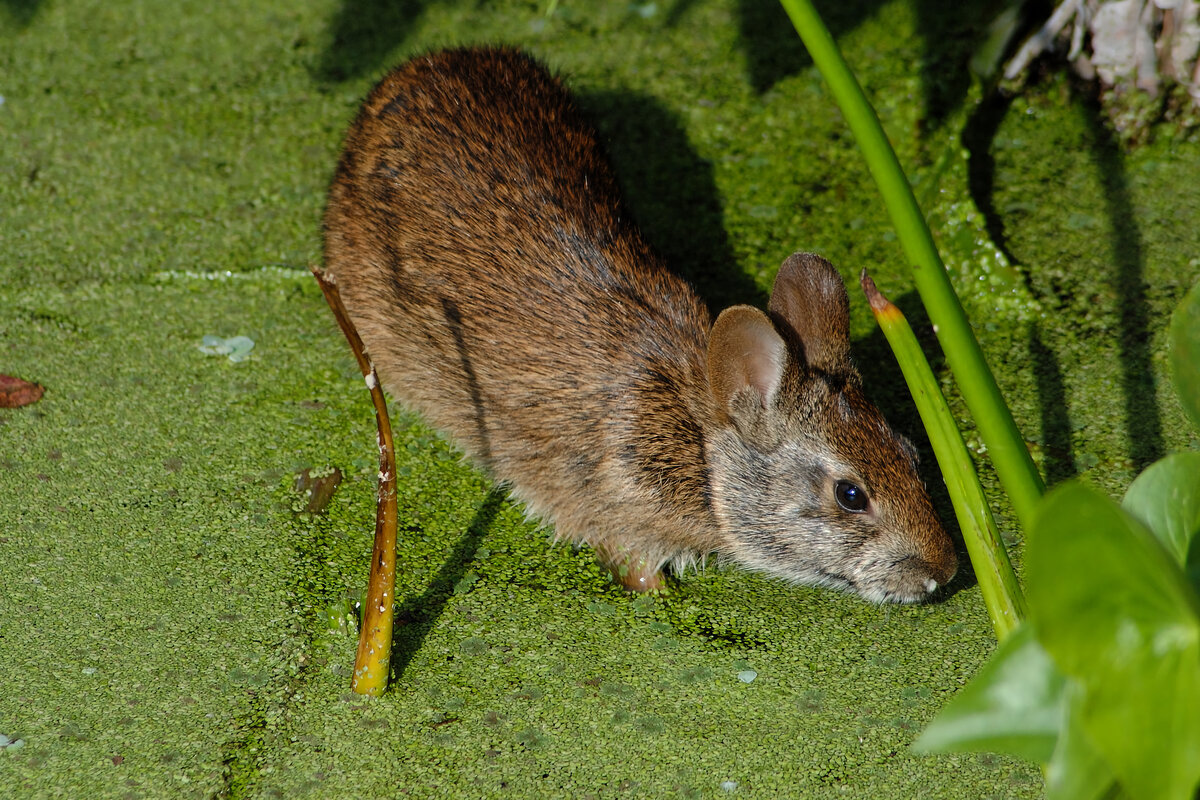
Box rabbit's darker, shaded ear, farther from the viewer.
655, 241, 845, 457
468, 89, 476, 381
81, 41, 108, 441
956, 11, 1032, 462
768, 253, 852, 373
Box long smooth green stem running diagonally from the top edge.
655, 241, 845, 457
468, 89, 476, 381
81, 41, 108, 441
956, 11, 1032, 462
780, 0, 1045, 530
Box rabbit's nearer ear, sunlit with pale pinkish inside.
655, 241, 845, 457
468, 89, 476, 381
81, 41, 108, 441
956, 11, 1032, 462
708, 306, 787, 435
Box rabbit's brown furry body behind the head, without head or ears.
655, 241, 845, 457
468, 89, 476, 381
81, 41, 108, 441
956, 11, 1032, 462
325, 49, 710, 551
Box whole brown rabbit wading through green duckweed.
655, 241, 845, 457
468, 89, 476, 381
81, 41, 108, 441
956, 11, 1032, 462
325, 49, 955, 601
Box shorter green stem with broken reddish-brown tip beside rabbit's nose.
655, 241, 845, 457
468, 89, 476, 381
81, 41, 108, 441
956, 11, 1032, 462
860, 270, 1026, 642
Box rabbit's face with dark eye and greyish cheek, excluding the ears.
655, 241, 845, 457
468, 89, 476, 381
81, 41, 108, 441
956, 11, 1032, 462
708, 378, 956, 602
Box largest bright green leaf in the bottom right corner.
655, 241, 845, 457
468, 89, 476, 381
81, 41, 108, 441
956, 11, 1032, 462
1026, 483, 1200, 800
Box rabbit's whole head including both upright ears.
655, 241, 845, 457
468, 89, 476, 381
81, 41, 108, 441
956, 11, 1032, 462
706, 253, 958, 602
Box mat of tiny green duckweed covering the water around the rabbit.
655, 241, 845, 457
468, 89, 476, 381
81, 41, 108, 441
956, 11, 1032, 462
0, 0, 1200, 799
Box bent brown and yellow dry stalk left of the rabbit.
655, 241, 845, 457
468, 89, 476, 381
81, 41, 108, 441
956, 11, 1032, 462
310, 265, 396, 697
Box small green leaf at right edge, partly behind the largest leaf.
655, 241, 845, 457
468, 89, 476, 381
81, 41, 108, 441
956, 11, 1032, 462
1121, 452, 1200, 575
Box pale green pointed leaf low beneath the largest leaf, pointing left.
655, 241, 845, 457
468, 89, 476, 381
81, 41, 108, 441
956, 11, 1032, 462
913, 624, 1066, 763
